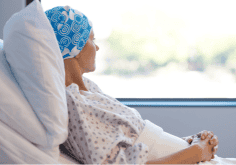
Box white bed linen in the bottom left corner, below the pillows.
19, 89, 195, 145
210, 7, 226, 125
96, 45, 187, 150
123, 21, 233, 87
0, 121, 58, 164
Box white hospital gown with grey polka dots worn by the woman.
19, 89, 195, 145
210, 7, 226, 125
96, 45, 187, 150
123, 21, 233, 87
64, 77, 149, 164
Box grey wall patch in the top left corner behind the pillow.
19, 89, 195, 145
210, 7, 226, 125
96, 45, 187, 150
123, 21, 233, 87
0, 0, 26, 39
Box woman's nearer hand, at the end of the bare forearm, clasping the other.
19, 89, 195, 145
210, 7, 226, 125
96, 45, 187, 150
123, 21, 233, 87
191, 134, 216, 162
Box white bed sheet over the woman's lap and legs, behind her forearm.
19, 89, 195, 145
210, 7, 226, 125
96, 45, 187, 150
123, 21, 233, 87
135, 120, 236, 165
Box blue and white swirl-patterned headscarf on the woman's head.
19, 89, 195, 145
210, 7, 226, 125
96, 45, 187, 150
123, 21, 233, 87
45, 6, 92, 59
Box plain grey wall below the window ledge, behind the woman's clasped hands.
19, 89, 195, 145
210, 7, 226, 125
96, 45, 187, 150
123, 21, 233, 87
134, 107, 236, 158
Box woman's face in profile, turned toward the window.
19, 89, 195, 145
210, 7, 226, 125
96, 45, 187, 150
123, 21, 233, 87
75, 29, 99, 73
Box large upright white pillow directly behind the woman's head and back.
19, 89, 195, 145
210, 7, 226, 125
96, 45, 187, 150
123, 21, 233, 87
3, 0, 68, 159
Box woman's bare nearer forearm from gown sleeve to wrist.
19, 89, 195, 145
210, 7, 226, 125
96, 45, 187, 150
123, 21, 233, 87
146, 144, 202, 164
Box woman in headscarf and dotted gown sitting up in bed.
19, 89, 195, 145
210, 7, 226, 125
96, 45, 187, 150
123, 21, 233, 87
45, 6, 219, 164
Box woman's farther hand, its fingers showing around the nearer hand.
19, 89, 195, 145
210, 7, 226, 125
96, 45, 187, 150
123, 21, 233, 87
182, 130, 219, 159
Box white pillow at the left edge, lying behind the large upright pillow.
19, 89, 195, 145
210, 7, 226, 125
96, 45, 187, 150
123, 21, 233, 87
0, 40, 47, 146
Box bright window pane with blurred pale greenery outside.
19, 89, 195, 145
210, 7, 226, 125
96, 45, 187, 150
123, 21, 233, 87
41, 0, 236, 98
